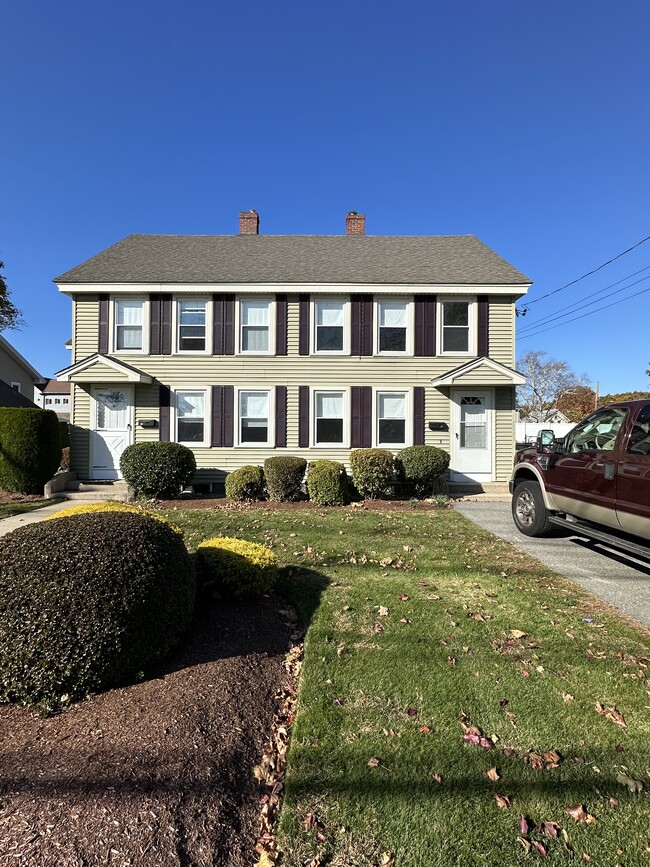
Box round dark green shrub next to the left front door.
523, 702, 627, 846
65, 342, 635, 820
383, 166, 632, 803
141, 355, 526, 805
120, 441, 196, 499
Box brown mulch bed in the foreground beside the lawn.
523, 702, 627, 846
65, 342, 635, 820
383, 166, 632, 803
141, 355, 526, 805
0, 598, 289, 867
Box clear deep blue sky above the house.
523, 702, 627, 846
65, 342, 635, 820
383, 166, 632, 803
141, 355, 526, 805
0, 0, 650, 393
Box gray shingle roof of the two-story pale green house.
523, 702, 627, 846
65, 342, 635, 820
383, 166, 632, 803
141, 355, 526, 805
55, 235, 531, 285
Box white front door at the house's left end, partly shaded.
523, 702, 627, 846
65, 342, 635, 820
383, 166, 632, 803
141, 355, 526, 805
90, 386, 133, 480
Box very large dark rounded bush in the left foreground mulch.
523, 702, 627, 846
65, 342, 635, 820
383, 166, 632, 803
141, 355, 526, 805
0, 512, 196, 709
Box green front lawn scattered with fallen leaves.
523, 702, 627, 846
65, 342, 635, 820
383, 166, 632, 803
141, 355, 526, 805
158, 508, 650, 867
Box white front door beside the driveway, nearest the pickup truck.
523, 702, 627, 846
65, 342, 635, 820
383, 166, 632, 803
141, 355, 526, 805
451, 390, 492, 482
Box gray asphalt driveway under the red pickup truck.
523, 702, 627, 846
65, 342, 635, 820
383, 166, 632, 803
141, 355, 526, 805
454, 502, 650, 627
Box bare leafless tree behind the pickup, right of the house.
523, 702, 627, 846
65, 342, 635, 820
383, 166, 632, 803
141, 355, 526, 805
517, 350, 593, 422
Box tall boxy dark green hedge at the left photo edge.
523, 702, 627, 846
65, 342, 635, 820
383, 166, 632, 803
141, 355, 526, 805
0, 406, 61, 494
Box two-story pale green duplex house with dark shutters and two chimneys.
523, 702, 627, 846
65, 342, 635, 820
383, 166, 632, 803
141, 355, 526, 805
55, 211, 530, 483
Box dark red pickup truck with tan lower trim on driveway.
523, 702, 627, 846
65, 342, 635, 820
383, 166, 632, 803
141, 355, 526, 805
510, 400, 650, 553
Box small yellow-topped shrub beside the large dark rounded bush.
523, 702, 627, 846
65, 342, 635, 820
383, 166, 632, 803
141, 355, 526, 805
197, 538, 278, 599
